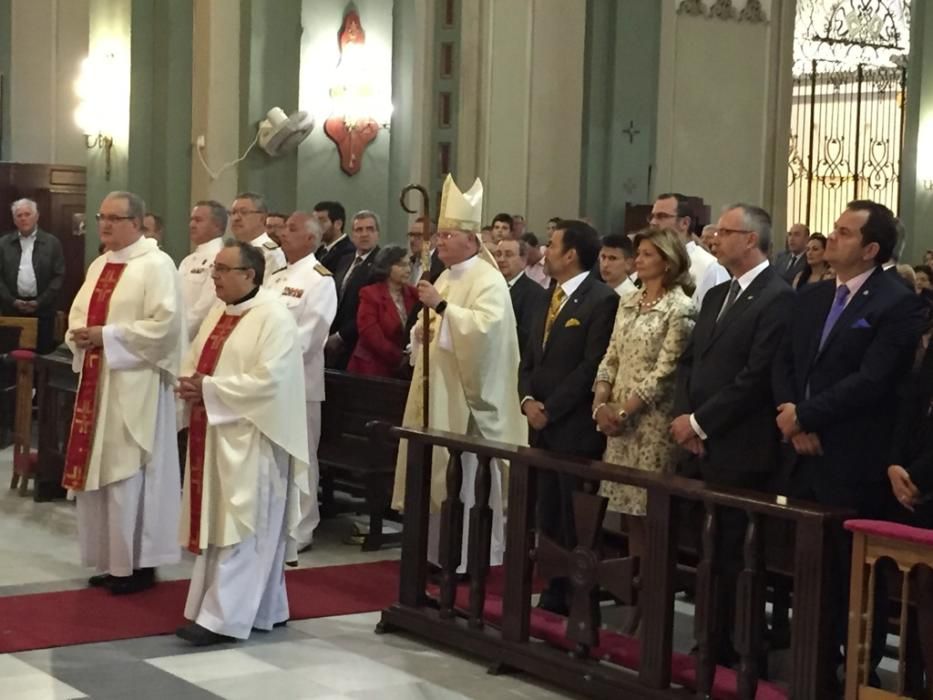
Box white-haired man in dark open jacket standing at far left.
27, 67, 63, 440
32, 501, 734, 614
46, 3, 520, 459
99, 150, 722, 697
0, 199, 65, 353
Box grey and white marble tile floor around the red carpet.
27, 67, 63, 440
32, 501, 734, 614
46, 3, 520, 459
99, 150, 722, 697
0, 450, 574, 700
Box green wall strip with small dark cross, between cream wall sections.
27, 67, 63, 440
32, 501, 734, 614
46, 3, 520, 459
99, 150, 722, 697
584, 0, 661, 233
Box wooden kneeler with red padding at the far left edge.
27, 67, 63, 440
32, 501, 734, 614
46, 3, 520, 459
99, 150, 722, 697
0, 316, 38, 496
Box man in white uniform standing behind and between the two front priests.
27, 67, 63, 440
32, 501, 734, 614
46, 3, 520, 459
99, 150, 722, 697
178, 200, 227, 338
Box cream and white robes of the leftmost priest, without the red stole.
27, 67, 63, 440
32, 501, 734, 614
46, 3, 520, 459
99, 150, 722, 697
67, 237, 185, 576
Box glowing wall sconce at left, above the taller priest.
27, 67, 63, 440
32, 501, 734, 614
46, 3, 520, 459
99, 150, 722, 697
74, 53, 120, 180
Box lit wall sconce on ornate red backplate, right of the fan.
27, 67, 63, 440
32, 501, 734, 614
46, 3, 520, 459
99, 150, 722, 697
324, 9, 392, 176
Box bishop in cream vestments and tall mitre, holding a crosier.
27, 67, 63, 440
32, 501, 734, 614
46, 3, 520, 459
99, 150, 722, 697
393, 175, 528, 573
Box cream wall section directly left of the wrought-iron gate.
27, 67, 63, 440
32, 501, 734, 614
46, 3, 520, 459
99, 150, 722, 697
653, 0, 793, 231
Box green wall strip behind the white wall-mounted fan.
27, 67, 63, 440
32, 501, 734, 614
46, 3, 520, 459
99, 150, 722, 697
238, 0, 302, 211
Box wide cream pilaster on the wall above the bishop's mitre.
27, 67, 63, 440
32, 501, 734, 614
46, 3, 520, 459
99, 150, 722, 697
453, 0, 586, 233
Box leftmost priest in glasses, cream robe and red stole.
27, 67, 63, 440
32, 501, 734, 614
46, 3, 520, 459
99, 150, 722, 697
62, 192, 186, 595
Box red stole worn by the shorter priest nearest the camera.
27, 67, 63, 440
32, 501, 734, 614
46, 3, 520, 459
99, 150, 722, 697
188, 314, 245, 554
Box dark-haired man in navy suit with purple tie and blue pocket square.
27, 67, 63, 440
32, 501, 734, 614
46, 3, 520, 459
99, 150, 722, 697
774, 200, 925, 688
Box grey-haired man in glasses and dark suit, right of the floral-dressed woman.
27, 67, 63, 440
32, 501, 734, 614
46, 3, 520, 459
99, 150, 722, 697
671, 204, 794, 663
